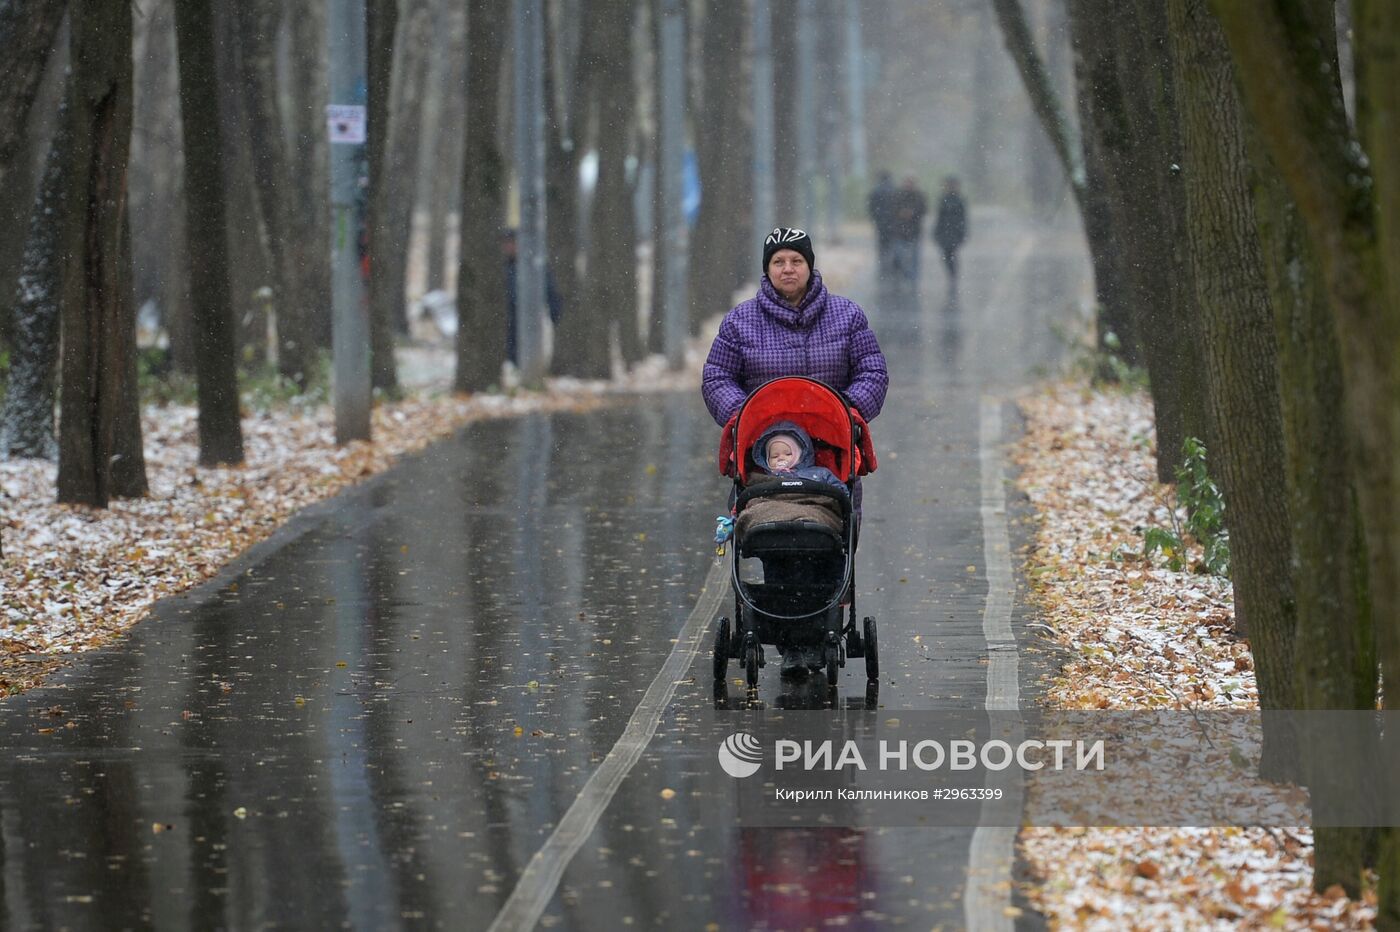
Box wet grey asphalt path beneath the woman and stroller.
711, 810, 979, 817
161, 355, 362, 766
0, 218, 1082, 929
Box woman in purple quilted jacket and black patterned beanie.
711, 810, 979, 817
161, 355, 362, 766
700, 227, 889, 672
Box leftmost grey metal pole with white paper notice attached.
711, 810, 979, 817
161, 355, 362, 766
326, 0, 379, 444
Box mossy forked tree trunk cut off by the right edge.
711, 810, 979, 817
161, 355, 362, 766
1212, 0, 1400, 912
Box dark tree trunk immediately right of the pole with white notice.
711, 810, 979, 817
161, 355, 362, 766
365, 0, 402, 392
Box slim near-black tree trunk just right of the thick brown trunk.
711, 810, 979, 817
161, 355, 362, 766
175, 0, 244, 466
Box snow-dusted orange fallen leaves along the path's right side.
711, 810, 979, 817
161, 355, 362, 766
1014, 382, 1376, 931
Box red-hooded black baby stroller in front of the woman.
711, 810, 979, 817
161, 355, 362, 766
714, 376, 879, 687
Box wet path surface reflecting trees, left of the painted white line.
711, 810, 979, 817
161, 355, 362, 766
0, 396, 722, 928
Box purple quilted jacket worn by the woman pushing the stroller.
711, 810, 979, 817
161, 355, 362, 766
700, 269, 889, 427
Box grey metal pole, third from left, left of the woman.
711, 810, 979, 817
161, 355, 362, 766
661, 0, 690, 369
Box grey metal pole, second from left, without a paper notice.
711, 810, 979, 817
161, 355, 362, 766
512, 0, 546, 386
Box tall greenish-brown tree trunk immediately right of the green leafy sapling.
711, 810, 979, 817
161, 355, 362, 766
1168, 0, 1302, 766
